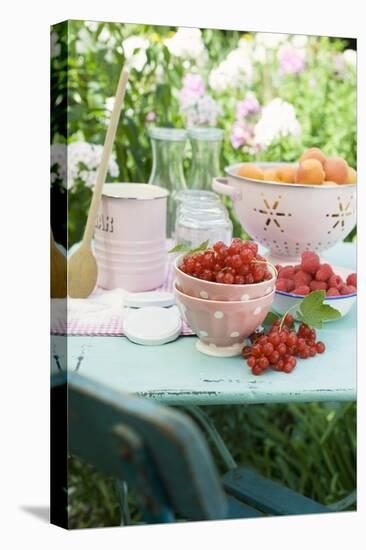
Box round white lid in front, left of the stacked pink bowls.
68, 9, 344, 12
123, 306, 182, 346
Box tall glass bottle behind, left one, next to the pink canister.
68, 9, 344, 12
148, 127, 187, 237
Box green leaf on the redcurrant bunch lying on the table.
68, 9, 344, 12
296, 290, 341, 328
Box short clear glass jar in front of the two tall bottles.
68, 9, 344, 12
175, 189, 233, 248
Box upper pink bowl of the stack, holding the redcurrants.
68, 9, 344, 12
174, 257, 277, 302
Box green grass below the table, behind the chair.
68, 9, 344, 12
68, 402, 356, 529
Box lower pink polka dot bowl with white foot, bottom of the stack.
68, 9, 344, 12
175, 285, 275, 357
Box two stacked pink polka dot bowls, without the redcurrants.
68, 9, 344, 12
175, 258, 277, 357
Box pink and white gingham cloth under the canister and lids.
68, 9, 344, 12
51, 258, 194, 336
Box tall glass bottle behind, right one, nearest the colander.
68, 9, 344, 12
188, 128, 224, 191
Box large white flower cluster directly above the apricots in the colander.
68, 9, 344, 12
254, 97, 301, 149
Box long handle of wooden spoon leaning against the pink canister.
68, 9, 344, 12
82, 69, 128, 247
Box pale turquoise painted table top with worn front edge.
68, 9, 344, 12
52, 244, 356, 405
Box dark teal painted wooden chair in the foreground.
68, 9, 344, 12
60, 373, 332, 523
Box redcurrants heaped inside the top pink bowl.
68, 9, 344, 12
179, 239, 273, 285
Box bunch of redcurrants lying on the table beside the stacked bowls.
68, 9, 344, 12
242, 322, 325, 375
